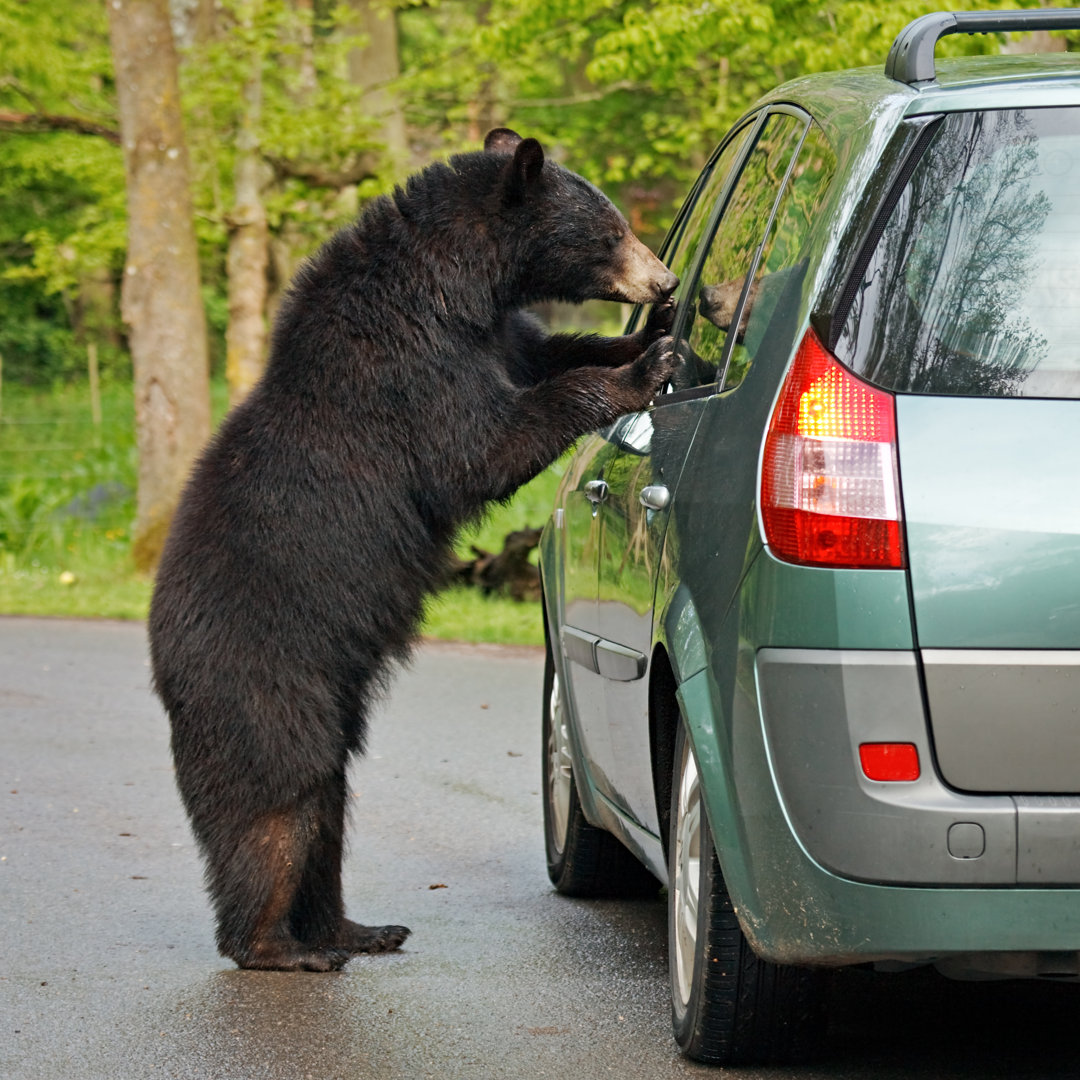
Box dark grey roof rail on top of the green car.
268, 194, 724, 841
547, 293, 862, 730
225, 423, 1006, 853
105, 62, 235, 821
885, 8, 1080, 86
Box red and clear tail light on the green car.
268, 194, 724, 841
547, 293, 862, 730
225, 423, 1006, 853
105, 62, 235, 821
761, 329, 904, 567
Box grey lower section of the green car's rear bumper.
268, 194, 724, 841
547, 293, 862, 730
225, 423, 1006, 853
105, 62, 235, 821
756, 649, 1080, 887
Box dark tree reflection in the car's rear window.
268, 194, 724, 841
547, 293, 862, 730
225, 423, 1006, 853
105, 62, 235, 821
838, 111, 1052, 396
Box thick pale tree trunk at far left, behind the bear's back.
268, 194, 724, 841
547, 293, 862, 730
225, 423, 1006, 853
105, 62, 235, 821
106, 0, 210, 571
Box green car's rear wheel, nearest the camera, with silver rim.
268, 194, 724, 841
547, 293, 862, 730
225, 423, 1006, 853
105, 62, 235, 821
667, 725, 826, 1065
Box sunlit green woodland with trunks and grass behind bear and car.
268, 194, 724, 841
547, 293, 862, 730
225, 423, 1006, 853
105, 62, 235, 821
0, 0, 1080, 642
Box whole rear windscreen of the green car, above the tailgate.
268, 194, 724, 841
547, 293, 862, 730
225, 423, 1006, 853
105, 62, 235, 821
836, 108, 1080, 397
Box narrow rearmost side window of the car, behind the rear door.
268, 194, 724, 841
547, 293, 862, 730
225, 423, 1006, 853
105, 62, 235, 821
721, 125, 836, 390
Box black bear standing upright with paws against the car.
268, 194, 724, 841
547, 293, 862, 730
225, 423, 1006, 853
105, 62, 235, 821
149, 129, 677, 971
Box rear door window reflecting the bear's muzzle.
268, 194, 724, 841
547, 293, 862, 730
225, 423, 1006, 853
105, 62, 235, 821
673, 112, 806, 387
